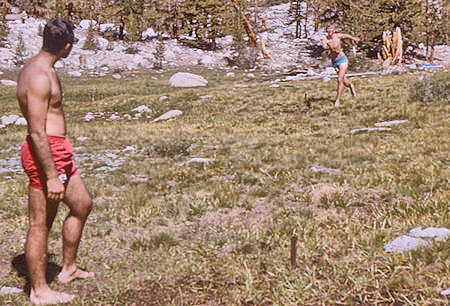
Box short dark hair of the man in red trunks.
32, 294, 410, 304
42, 18, 75, 54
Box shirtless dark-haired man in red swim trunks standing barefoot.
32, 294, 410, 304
16, 18, 93, 304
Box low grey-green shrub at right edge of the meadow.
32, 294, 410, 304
408, 72, 450, 102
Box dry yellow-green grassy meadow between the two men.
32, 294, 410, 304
0, 70, 450, 305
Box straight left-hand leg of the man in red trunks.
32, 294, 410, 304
25, 187, 75, 304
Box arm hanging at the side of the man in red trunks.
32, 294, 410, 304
27, 73, 64, 200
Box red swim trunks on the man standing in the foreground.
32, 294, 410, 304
22, 135, 77, 190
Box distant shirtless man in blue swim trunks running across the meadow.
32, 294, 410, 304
322, 24, 359, 107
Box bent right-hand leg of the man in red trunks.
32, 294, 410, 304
58, 173, 94, 283
